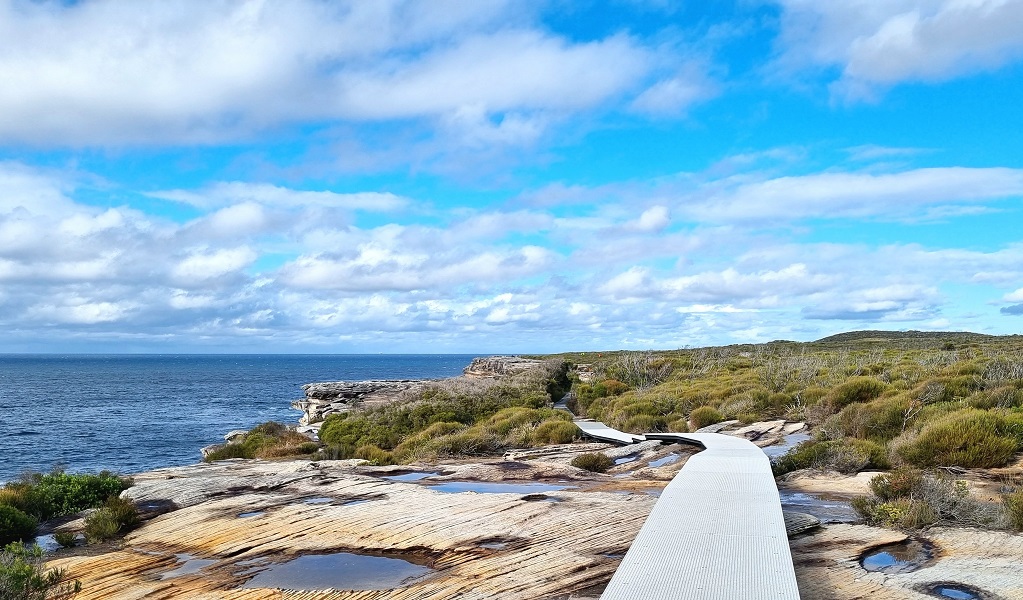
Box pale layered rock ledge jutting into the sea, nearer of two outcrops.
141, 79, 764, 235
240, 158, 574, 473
292, 379, 427, 425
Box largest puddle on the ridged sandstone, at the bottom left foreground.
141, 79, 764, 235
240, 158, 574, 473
242, 552, 434, 590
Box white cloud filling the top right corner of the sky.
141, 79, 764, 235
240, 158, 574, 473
780, 0, 1023, 99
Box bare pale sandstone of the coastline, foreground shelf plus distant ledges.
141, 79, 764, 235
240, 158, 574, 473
34, 357, 1023, 600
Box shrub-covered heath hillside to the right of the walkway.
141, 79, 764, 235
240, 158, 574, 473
566, 331, 1023, 471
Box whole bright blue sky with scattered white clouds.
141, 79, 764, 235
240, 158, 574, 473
0, 0, 1023, 353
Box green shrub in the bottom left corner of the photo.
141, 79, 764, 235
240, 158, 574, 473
0, 543, 82, 600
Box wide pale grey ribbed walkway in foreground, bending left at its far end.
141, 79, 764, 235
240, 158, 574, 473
601, 433, 799, 600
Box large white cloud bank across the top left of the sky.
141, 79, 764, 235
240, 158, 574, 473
0, 0, 654, 145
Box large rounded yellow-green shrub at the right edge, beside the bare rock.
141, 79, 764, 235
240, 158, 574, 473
895, 409, 1020, 468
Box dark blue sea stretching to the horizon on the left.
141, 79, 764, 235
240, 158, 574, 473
0, 355, 473, 481
